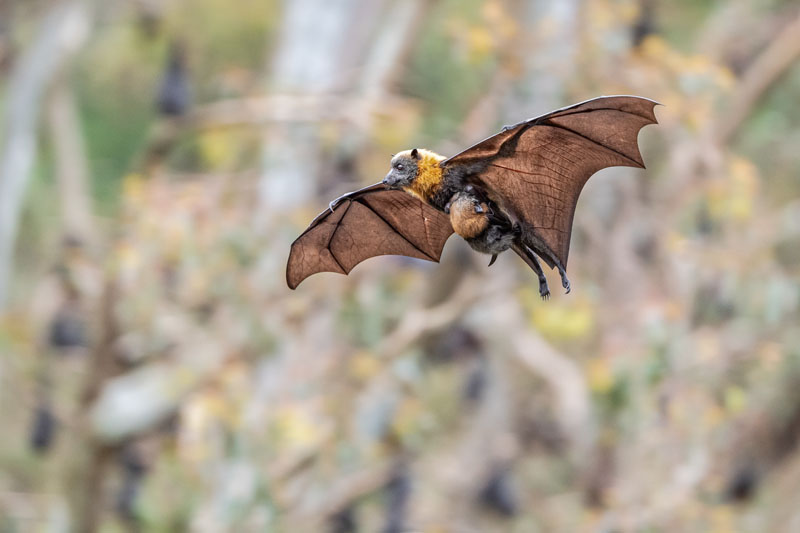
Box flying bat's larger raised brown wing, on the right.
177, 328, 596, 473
442, 96, 658, 267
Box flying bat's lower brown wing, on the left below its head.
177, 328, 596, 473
286, 183, 453, 289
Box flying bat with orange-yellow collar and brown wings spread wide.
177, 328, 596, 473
286, 96, 657, 298
